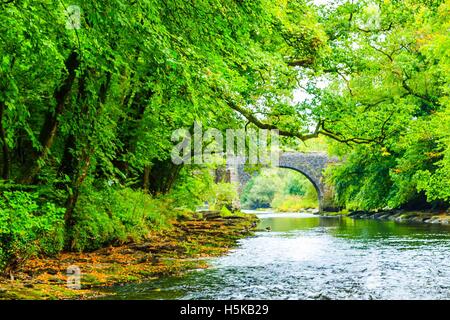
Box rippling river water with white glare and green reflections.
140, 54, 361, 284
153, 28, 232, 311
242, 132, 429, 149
102, 213, 450, 299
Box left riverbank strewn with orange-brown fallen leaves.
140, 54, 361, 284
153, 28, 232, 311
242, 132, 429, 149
0, 212, 258, 299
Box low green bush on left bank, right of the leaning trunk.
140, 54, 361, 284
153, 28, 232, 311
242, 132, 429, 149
69, 188, 175, 251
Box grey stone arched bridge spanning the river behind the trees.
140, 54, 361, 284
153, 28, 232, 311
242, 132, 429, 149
227, 152, 338, 212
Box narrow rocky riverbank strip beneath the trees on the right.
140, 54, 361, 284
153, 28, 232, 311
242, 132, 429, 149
319, 210, 450, 224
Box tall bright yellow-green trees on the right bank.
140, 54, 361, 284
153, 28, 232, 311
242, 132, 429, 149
321, 1, 450, 209
